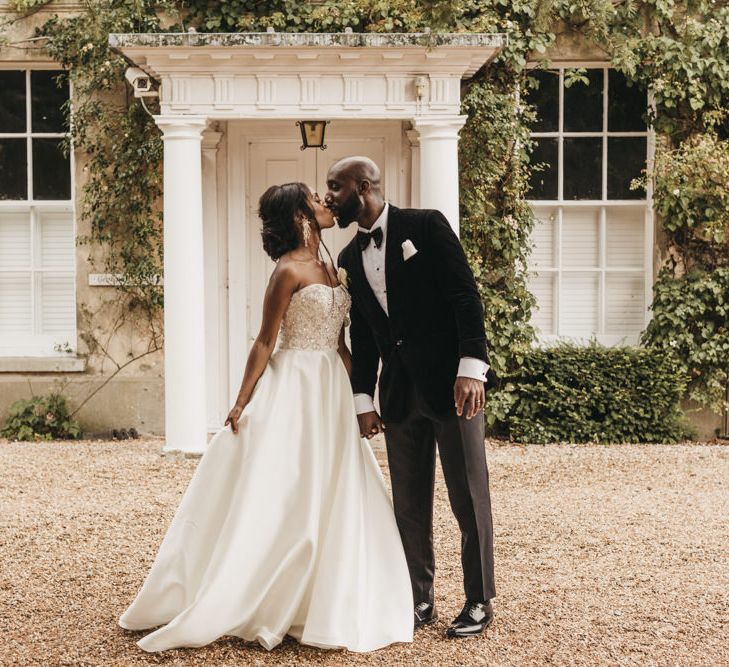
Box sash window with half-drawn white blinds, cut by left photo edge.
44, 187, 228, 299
0, 70, 76, 356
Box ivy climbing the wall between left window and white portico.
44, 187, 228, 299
39, 1, 170, 316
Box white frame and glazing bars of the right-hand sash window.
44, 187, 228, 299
527, 61, 655, 345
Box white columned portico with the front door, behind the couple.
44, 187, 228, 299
109, 33, 504, 453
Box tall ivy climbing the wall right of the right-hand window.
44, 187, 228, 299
621, 0, 729, 412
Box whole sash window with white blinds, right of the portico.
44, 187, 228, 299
527, 67, 652, 344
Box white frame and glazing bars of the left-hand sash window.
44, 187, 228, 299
0, 66, 78, 357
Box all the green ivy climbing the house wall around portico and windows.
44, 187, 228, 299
2, 0, 729, 422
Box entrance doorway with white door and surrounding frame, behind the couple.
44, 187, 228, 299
228, 120, 410, 414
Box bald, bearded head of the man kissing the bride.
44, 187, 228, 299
325, 155, 384, 227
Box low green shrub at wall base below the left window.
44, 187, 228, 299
0, 392, 81, 440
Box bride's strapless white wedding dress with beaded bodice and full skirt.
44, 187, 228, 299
119, 284, 413, 651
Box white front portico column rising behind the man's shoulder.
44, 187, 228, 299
413, 116, 466, 234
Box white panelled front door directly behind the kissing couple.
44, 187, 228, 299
246, 137, 385, 349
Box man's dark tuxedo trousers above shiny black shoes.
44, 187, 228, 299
385, 380, 496, 604
